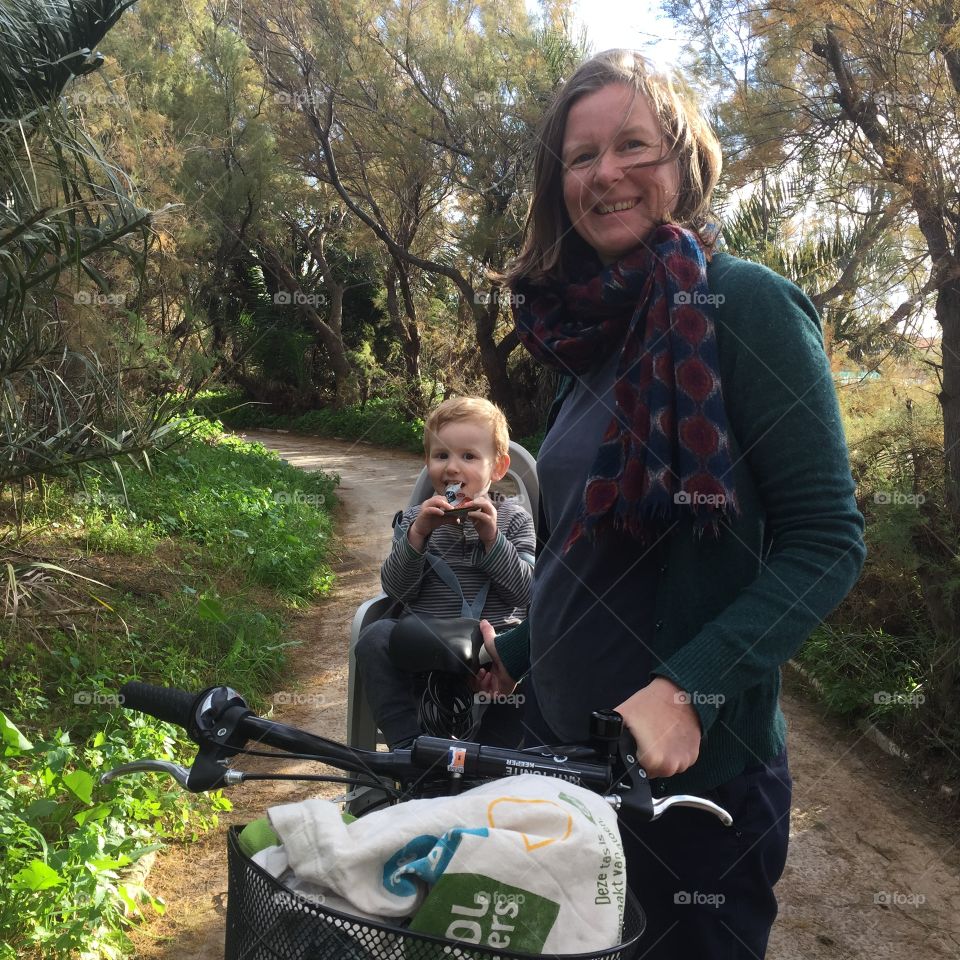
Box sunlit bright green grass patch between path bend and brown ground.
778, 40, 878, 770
46, 418, 339, 599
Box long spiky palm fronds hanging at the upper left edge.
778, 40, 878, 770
0, 0, 169, 496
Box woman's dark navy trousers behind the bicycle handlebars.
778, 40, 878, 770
524, 678, 793, 960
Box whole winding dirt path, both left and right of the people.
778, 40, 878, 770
135, 431, 960, 960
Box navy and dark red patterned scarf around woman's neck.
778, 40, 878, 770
511, 224, 739, 553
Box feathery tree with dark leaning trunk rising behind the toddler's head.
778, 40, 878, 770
243, 0, 582, 432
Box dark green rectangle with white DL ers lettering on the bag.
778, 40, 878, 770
410, 873, 560, 953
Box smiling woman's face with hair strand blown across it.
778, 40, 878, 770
561, 83, 680, 264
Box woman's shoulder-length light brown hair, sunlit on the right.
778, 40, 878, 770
502, 50, 723, 286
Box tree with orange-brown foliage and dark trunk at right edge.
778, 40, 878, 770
669, 0, 960, 717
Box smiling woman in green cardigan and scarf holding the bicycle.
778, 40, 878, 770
481, 50, 865, 960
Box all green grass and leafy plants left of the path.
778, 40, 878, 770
0, 420, 337, 960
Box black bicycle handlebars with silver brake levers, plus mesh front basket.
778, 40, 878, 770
101, 668, 732, 960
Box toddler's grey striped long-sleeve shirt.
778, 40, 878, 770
380, 500, 536, 629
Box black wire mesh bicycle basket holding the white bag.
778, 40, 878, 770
225, 827, 646, 960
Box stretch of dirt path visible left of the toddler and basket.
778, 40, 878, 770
133, 431, 421, 960
